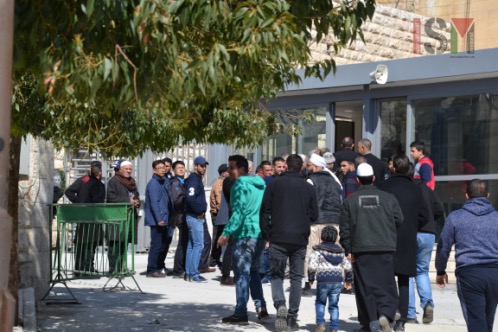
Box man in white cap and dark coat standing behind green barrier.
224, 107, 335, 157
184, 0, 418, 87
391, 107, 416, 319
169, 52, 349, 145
106, 160, 140, 274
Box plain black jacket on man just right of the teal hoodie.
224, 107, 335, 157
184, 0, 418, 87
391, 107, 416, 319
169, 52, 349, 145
260, 172, 318, 247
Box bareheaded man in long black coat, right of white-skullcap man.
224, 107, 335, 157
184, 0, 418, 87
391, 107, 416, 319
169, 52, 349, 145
378, 155, 430, 331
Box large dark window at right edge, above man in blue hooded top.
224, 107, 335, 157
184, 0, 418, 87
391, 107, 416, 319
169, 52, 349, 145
412, 94, 498, 175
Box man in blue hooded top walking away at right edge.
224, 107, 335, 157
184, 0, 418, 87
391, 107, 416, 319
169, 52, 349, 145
436, 179, 498, 332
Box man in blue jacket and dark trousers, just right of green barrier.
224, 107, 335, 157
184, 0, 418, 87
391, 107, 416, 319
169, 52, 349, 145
145, 160, 173, 278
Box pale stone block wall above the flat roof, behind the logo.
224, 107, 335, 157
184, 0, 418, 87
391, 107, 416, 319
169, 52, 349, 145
311, 5, 450, 65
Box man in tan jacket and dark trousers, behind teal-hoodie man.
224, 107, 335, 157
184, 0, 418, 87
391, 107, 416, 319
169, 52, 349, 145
209, 164, 228, 267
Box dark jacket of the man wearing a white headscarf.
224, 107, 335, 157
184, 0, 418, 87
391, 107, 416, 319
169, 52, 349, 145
308, 171, 342, 224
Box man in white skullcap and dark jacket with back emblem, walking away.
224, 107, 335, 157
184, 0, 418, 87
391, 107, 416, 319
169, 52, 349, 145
339, 163, 403, 332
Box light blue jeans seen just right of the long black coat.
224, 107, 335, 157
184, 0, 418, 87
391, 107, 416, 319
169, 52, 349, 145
408, 233, 436, 318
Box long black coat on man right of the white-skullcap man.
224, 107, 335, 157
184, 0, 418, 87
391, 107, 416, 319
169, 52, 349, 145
379, 174, 430, 276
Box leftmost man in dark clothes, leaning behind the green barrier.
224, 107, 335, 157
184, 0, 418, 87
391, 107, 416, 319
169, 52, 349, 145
75, 165, 105, 274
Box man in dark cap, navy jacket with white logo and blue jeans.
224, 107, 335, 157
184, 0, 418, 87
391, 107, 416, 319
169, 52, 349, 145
185, 156, 209, 282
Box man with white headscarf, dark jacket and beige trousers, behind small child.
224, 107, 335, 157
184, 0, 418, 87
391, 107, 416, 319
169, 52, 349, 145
303, 153, 342, 296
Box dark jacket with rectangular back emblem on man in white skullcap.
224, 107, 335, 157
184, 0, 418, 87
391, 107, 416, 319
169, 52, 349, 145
339, 185, 404, 255
